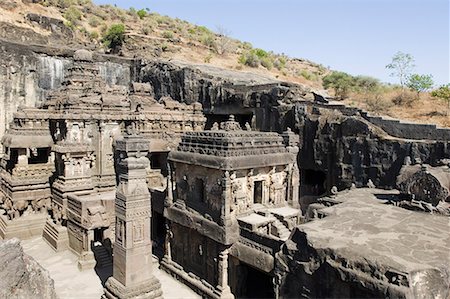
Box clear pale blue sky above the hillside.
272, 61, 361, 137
94, 0, 450, 85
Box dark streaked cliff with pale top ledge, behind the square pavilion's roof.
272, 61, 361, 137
140, 61, 312, 131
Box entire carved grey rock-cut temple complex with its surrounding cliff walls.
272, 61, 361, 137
0, 47, 450, 299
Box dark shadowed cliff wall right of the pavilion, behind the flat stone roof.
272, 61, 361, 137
294, 107, 450, 195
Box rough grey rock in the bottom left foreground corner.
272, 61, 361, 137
0, 239, 57, 298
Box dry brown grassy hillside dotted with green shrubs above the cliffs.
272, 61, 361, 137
0, 0, 450, 126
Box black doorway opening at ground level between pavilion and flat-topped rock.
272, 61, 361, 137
231, 262, 275, 298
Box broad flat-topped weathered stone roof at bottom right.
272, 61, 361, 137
277, 189, 450, 298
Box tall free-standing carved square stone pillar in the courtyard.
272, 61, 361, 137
105, 125, 162, 298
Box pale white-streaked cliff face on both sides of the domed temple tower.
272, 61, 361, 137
0, 41, 136, 149
